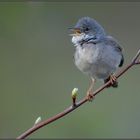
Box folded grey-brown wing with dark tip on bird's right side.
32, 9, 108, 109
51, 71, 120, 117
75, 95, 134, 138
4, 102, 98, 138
105, 36, 124, 67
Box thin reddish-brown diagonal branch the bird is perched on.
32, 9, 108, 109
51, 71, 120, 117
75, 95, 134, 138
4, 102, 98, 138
17, 49, 140, 139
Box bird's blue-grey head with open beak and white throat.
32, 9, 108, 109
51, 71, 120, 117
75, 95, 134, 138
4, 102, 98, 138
71, 17, 106, 45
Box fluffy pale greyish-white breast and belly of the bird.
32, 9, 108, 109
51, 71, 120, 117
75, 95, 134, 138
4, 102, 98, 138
74, 44, 120, 79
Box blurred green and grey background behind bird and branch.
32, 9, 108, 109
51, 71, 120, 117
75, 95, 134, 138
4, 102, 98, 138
0, 2, 140, 138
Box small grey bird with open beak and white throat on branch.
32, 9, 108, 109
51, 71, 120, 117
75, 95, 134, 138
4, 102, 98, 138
70, 17, 124, 100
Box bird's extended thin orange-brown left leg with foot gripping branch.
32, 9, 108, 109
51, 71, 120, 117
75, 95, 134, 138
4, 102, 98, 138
86, 78, 95, 101
